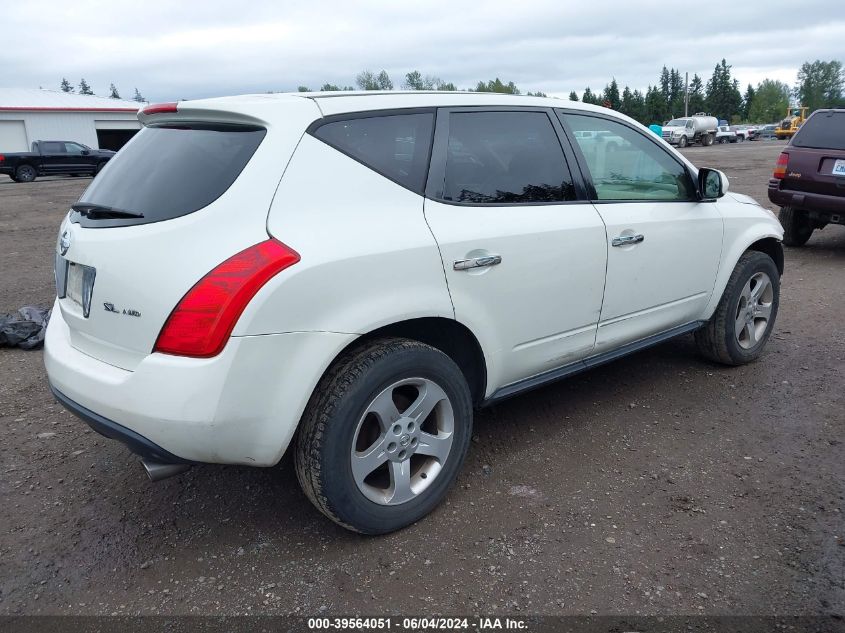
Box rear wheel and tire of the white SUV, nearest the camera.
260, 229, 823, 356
296, 338, 472, 534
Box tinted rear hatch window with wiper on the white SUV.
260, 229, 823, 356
70, 124, 267, 228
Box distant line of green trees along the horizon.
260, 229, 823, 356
56, 59, 845, 125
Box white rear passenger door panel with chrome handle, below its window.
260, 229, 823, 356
425, 200, 607, 395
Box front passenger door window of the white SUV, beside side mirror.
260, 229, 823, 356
561, 114, 695, 200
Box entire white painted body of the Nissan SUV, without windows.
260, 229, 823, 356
44, 92, 782, 466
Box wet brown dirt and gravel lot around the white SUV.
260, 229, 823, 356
0, 142, 845, 615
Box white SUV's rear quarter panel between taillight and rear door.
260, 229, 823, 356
244, 135, 454, 334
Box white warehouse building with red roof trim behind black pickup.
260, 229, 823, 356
0, 88, 145, 153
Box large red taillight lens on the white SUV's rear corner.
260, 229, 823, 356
153, 240, 299, 358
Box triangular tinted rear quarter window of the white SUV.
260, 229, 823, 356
314, 113, 434, 193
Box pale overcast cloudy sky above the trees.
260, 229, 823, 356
0, 0, 845, 101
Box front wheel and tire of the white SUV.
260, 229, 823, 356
695, 251, 780, 365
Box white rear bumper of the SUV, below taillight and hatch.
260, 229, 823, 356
44, 309, 355, 466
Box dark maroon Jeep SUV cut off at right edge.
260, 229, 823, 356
769, 109, 845, 246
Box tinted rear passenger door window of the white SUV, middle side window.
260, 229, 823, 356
443, 112, 575, 203
